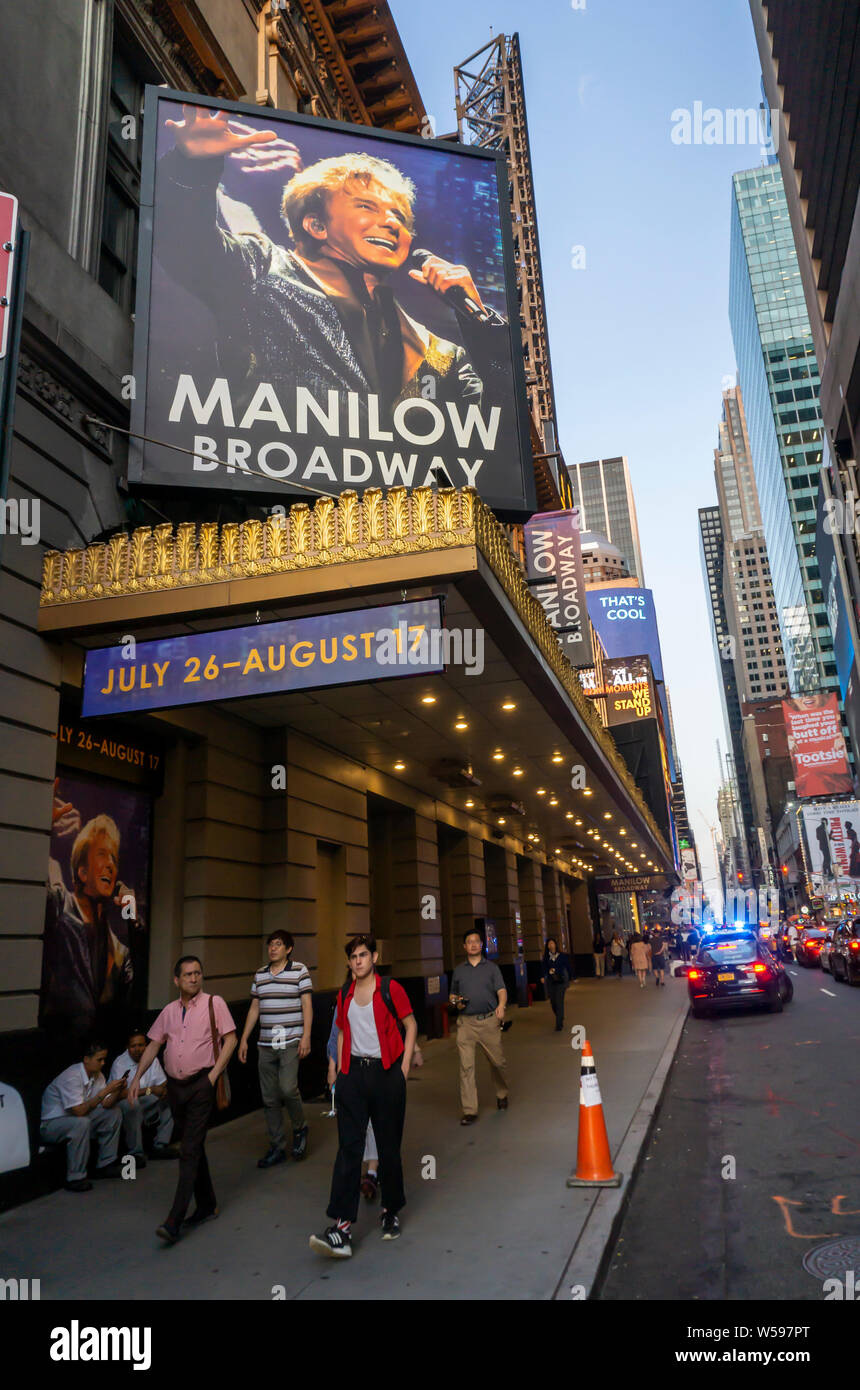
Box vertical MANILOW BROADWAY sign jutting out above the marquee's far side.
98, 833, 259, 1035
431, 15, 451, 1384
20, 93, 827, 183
524, 507, 592, 666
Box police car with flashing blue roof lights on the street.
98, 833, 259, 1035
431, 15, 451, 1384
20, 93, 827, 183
686, 931, 795, 1019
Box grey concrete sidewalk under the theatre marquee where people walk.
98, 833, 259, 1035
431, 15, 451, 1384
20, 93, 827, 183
0, 976, 686, 1300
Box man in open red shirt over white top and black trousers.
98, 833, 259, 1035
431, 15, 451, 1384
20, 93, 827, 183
310, 935, 418, 1259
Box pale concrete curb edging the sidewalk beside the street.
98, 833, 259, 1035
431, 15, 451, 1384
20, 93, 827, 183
553, 1002, 688, 1301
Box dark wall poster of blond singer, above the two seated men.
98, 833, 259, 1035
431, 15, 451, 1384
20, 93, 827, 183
39, 774, 150, 1038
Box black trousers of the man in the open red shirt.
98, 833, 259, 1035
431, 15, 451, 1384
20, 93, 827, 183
326, 1058, 406, 1220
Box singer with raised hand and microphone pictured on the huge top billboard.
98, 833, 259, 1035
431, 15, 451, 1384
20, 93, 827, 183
156, 106, 507, 418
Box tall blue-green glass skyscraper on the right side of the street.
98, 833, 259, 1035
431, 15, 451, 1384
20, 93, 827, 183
729, 164, 838, 694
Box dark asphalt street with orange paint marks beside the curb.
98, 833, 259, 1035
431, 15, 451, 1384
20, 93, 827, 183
600, 965, 860, 1301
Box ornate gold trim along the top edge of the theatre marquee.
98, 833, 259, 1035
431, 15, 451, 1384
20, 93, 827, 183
40, 488, 671, 863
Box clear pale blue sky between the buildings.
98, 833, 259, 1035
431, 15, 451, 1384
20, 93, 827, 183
390, 0, 761, 887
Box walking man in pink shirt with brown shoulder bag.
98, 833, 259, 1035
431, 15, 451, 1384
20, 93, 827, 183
128, 956, 236, 1245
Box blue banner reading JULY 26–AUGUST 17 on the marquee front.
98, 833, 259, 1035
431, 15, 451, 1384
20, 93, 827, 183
82, 598, 450, 719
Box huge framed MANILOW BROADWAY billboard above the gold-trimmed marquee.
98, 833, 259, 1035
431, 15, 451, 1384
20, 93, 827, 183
129, 88, 535, 517
